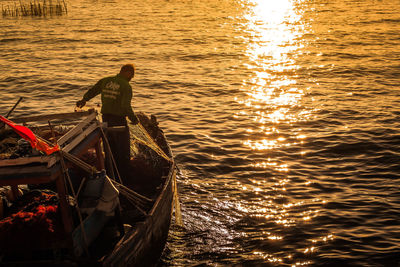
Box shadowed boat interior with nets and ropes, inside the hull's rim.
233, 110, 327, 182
0, 111, 174, 266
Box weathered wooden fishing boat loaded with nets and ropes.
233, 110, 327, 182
0, 110, 176, 266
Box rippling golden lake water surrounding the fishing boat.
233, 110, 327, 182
0, 0, 400, 266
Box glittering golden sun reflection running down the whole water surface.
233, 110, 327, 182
235, 0, 333, 266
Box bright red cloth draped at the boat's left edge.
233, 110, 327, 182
0, 115, 60, 155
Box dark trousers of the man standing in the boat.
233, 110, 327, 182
103, 114, 131, 181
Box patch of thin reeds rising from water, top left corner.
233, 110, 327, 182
1, 0, 68, 17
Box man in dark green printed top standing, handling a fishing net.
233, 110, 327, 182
76, 64, 138, 183
